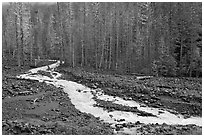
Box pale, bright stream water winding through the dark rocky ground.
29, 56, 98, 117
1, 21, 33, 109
17, 61, 202, 134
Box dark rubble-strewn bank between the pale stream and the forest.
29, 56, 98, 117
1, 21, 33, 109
58, 67, 202, 117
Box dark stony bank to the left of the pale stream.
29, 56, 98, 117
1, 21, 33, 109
2, 60, 113, 135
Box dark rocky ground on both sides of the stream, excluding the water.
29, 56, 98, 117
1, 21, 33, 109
2, 60, 202, 135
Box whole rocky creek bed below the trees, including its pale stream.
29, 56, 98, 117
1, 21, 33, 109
2, 60, 202, 134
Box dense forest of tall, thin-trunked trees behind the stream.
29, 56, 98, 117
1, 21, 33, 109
2, 2, 202, 77
